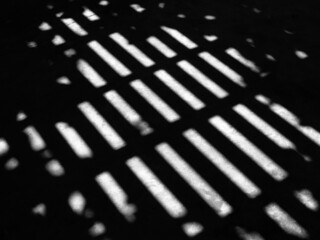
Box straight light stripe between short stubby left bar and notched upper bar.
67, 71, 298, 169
88, 41, 131, 77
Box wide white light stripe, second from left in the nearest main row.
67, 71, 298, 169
126, 157, 187, 218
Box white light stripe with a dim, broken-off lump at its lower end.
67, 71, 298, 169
104, 90, 153, 136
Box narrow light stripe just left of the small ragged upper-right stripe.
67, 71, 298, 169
199, 52, 246, 87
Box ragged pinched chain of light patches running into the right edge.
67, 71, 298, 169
256, 95, 320, 146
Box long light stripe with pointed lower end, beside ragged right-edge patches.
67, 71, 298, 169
233, 104, 296, 149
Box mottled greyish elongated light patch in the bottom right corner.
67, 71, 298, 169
265, 203, 308, 239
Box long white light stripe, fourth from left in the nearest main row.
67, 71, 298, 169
183, 129, 261, 198
